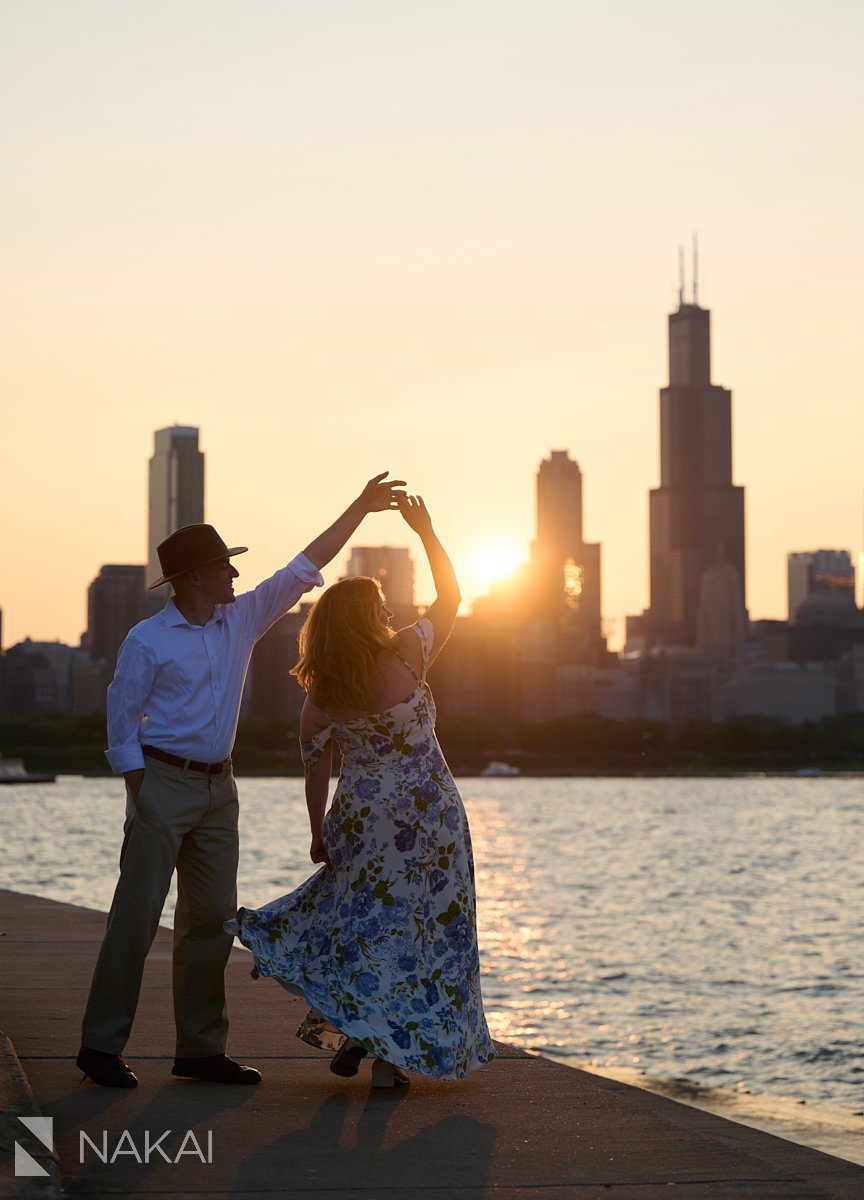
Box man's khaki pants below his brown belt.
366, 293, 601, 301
82, 757, 239, 1058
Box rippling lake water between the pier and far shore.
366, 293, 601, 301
0, 776, 864, 1162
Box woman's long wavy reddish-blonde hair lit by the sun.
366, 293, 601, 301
290, 575, 394, 712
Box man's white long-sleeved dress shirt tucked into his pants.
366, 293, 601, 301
106, 554, 324, 775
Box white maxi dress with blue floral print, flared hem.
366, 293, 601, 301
226, 618, 496, 1079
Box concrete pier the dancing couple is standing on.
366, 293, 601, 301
0, 892, 864, 1200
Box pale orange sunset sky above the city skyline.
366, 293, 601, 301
0, 0, 864, 646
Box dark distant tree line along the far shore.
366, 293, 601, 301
0, 713, 864, 775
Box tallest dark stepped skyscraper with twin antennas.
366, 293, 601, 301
646, 274, 746, 646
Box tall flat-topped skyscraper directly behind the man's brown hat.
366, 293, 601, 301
148, 425, 204, 611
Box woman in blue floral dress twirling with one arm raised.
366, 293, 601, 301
226, 494, 496, 1087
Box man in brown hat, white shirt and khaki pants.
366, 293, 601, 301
77, 472, 404, 1087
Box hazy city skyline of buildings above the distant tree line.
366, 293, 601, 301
0, 434, 864, 724
